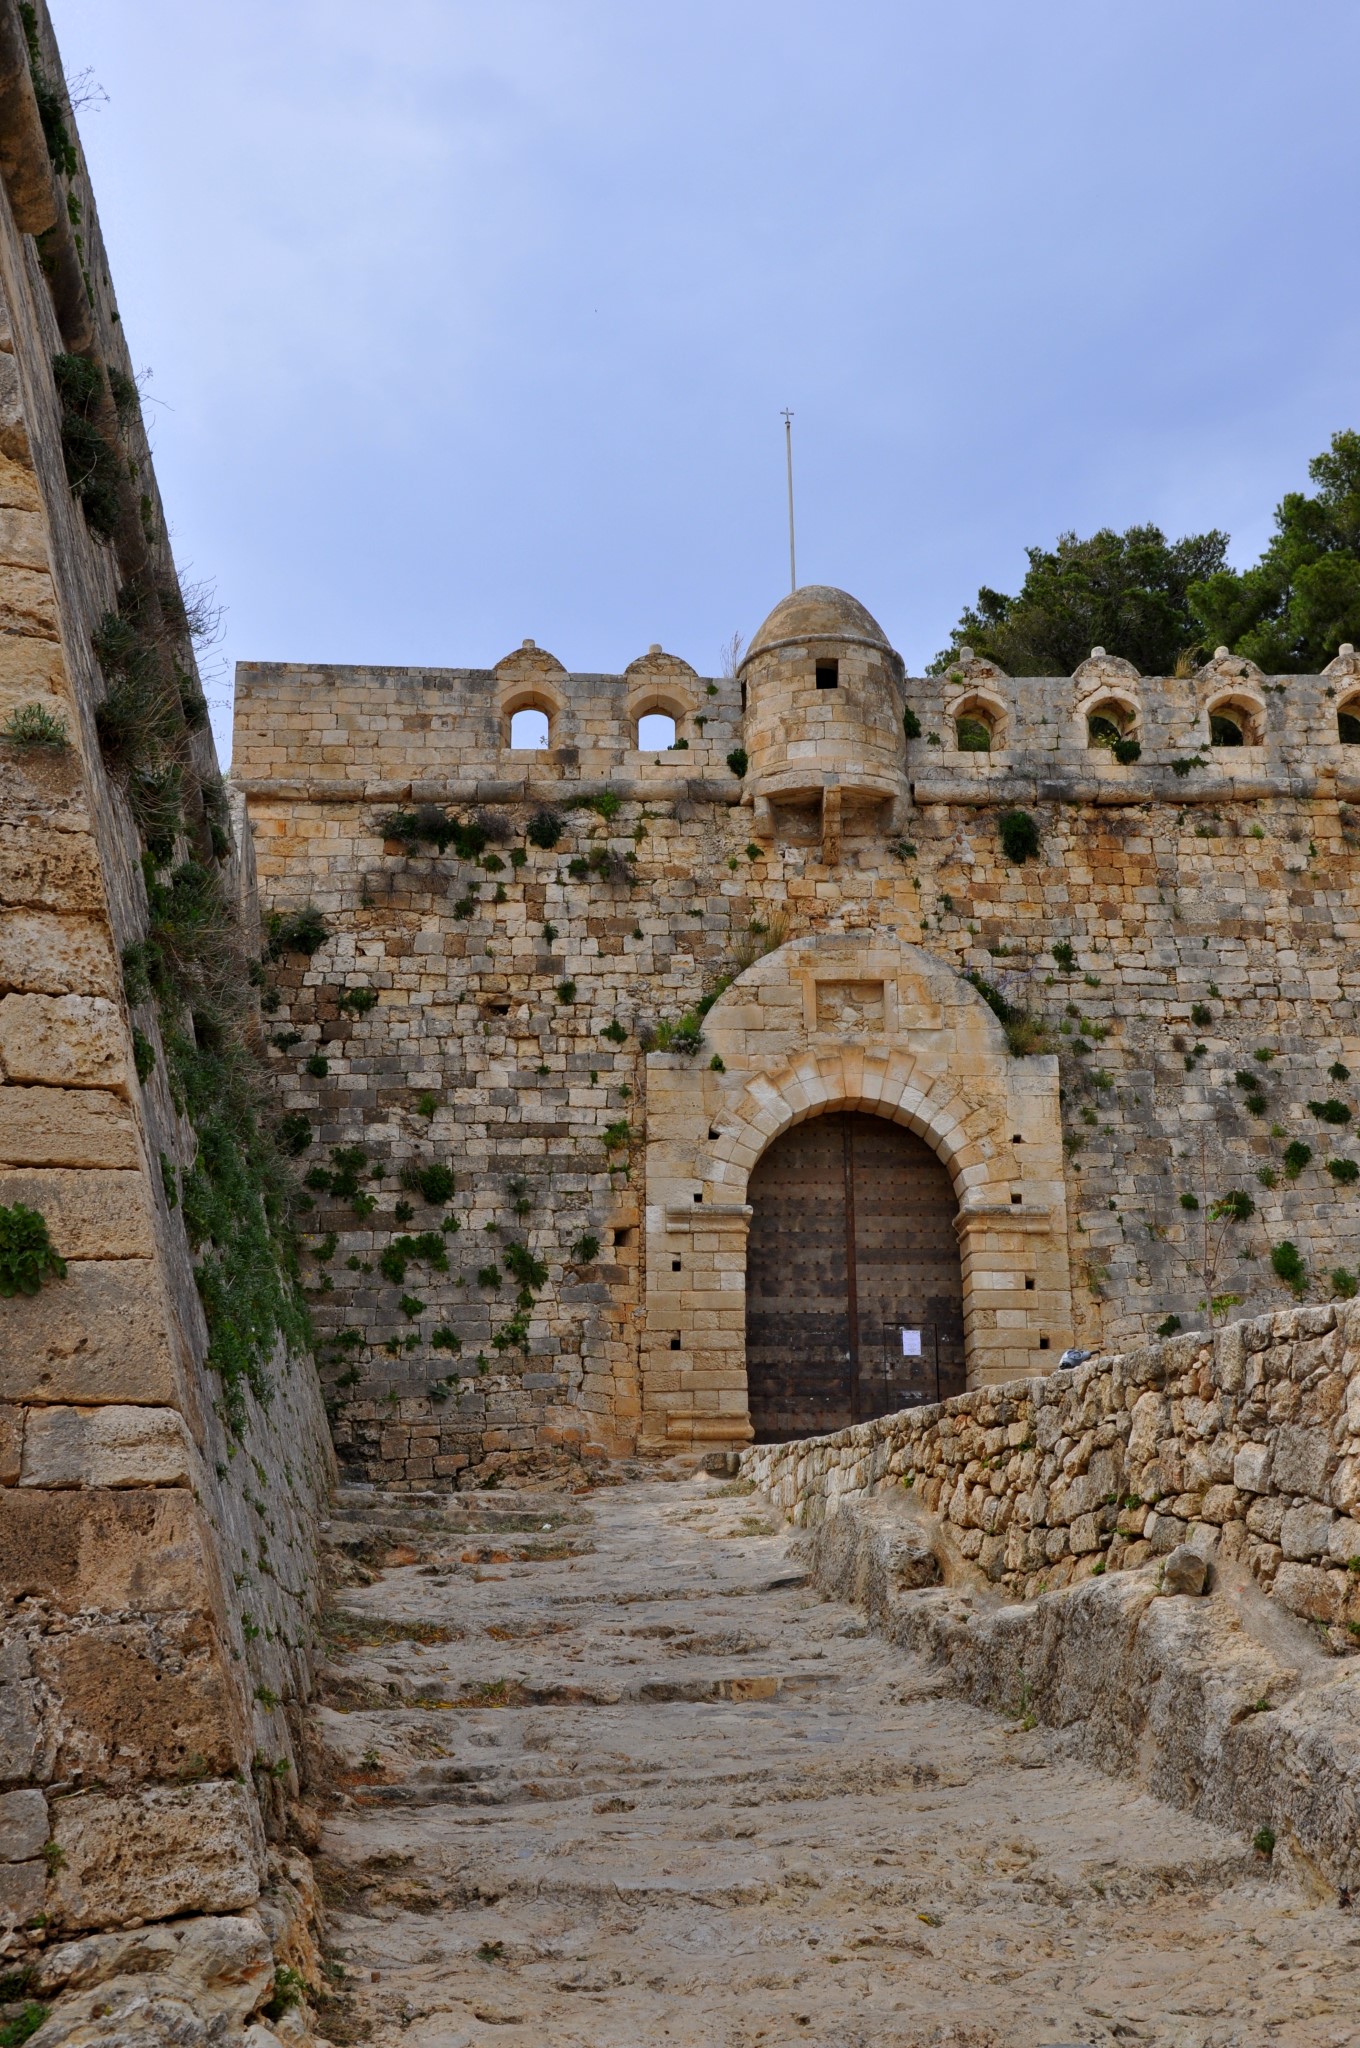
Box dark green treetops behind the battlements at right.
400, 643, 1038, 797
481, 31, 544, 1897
930, 430, 1360, 676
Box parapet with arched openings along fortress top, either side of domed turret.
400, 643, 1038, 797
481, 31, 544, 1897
233, 647, 1360, 805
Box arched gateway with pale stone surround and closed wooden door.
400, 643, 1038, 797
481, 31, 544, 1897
637, 932, 1071, 1448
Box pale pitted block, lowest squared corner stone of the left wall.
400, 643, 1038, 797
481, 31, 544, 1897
51, 1782, 264, 1927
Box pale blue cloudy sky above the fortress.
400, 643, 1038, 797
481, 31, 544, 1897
51, 0, 1360, 756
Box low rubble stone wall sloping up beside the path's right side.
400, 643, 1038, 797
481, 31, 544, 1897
741, 1303, 1360, 1655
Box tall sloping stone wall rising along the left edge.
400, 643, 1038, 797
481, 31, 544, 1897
0, 0, 330, 1982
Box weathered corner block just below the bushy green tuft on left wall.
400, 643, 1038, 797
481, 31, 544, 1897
0, 1260, 176, 1405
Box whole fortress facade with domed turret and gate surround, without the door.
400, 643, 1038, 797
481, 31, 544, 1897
233, 586, 1360, 1485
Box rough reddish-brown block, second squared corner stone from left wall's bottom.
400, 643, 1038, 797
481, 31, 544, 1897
33, 1614, 248, 1786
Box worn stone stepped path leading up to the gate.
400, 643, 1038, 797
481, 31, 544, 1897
313, 1479, 1360, 2048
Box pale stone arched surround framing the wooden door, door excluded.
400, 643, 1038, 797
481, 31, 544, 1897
641, 932, 1071, 1444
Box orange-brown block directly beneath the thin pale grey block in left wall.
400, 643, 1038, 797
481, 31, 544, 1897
0, 1487, 225, 1614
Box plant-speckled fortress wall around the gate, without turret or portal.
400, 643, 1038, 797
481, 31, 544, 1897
236, 649, 1360, 1485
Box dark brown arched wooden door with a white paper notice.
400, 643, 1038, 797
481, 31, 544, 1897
746, 1110, 965, 1444
